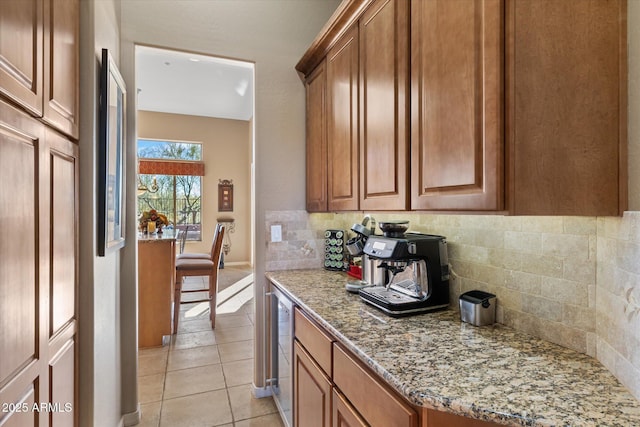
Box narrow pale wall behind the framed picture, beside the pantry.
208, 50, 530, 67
78, 0, 126, 426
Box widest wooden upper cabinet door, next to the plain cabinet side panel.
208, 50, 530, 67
411, 0, 504, 210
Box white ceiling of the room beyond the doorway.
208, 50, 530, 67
136, 46, 254, 120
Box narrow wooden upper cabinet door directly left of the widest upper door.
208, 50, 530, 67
359, 0, 409, 210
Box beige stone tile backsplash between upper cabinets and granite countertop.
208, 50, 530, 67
265, 211, 640, 399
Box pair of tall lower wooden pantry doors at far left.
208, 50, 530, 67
0, 102, 78, 427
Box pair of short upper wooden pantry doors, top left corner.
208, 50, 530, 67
0, 0, 80, 138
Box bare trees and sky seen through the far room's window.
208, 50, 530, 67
138, 139, 202, 240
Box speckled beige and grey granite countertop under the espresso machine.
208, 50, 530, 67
267, 269, 640, 427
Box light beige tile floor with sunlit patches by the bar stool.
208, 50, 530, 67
138, 270, 283, 427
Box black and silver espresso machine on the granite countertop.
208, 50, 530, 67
359, 221, 449, 317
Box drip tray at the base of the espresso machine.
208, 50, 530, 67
360, 286, 449, 317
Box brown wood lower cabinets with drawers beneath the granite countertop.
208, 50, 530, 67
293, 307, 504, 427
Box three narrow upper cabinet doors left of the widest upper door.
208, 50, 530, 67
298, 0, 409, 212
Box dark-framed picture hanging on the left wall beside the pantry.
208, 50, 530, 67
98, 49, 127, 256
